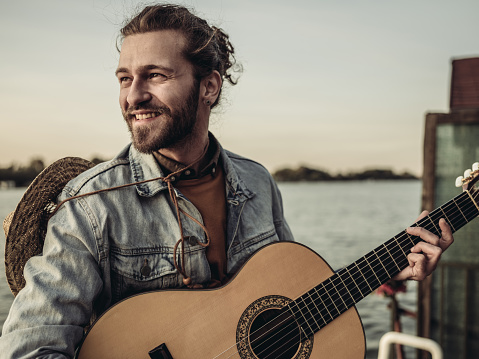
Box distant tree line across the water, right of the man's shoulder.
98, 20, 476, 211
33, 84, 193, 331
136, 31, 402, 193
273, 166, 418, 182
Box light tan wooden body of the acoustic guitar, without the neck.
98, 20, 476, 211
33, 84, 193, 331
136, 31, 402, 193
78, 242, 365, 359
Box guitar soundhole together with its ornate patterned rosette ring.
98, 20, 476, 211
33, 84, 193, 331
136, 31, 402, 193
236, 295, 313, 359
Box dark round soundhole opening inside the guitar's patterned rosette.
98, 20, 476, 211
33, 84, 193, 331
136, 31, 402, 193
250, 309, 301, 359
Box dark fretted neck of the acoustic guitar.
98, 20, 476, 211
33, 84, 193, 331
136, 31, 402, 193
286, 192, 479, 337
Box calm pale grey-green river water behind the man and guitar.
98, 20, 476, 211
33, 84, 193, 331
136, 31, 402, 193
0, 181, 421, 359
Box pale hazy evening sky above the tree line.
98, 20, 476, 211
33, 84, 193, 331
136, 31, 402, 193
0, 0, 479, 175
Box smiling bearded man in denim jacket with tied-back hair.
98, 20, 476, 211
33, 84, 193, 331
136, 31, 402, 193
0, 5, 453, 358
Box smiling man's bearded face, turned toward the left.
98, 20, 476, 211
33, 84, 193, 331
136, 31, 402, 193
116, 30, 199, 153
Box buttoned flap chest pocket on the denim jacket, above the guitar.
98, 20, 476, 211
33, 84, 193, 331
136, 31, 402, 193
110, 247, 180, 302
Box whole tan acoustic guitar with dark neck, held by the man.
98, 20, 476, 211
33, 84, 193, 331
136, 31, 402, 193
78, 164, 479, 359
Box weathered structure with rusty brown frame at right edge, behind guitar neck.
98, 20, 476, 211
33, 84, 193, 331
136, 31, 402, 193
418, 57, 479, 359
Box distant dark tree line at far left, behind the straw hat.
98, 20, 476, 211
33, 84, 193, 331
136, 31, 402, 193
0, 157, 105, 187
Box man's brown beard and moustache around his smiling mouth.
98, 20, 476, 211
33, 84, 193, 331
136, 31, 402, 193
123, 81, 199, 154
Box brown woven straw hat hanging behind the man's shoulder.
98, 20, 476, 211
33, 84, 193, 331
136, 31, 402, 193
3, 157, 94, 296
